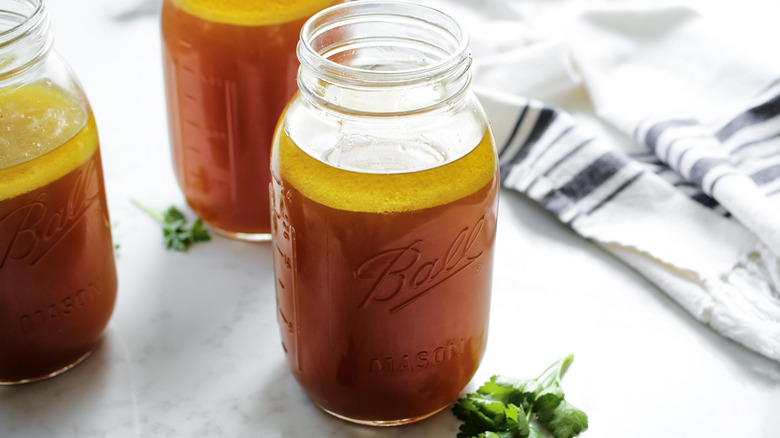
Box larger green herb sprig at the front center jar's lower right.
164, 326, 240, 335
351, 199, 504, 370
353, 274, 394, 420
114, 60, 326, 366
452, 354, 588, 438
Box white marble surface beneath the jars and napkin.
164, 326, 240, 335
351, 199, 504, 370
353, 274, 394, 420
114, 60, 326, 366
0, 0, 780, 438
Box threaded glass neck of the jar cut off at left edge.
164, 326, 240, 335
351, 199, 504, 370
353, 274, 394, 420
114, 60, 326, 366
0, 0, 52, 82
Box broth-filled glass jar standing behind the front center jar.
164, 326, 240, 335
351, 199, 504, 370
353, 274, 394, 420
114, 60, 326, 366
161, 0, 337, 241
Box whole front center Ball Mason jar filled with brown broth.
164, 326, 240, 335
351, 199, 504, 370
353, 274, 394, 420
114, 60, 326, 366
271, 1, 499, 425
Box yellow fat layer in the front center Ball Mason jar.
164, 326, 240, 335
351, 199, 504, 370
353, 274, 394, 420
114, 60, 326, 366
276, 131, 496, 213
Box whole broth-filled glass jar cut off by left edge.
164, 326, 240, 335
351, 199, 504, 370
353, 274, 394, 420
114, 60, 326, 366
0, 0, 117, 384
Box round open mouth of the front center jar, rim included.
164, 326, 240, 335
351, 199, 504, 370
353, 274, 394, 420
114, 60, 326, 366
298, 1, 471, 85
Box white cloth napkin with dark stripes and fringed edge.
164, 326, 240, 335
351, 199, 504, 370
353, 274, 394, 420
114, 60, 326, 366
428, 0, 780, 360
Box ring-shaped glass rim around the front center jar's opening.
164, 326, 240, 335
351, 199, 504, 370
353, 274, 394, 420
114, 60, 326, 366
298, 0, 471, 85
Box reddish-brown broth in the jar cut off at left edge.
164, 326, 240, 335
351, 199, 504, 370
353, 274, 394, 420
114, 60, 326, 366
0, 116, 117, 383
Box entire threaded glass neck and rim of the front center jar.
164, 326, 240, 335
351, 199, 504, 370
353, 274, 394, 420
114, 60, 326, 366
298, 1, 471, 116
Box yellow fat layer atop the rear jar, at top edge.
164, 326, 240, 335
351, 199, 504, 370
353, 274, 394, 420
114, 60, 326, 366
172, 0, 334, 26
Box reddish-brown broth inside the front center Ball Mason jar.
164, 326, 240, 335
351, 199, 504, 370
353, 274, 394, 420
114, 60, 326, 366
273, 129, 498, 422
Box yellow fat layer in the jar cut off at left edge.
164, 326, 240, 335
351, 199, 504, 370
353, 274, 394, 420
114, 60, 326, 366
0, 83, 98, 201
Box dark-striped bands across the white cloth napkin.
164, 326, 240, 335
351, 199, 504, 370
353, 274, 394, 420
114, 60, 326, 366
498, 79, 780, 243
